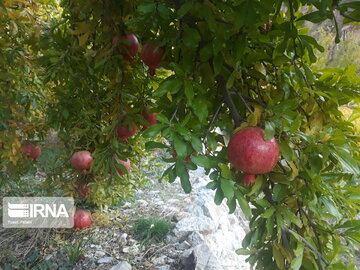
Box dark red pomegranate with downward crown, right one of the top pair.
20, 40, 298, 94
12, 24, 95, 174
141, 42, 165, 75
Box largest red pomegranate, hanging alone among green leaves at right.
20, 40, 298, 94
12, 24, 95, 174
228, 127, 279, 174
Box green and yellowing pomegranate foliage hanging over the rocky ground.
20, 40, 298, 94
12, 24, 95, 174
0, 0, 360, 269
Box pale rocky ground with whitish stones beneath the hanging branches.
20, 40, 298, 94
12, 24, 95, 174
0, 170, 250, 270
